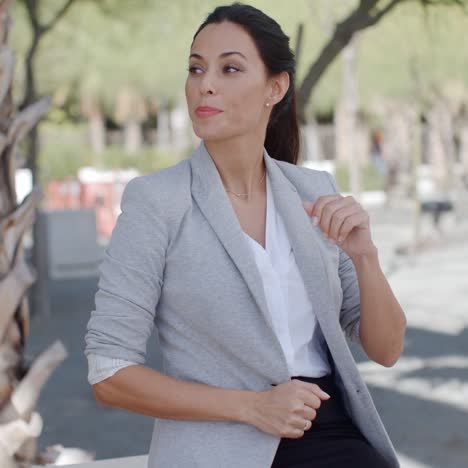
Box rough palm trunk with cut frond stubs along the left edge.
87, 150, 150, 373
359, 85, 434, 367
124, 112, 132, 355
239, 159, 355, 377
0, 0, 94, 468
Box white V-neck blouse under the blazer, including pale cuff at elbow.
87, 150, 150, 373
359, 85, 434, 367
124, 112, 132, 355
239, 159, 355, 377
88, 172, 331, 385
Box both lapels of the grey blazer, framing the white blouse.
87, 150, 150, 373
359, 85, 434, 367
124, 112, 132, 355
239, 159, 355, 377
190, 140, 333, 378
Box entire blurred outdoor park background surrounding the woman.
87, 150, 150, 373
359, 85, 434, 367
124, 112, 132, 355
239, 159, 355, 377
0, 0, 468, 468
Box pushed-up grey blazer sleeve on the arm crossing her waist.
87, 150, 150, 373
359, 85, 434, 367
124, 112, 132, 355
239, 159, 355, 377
84, 176, 168, 364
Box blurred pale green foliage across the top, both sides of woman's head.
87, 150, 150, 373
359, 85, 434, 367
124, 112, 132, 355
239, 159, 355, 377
11, 0, 468, 115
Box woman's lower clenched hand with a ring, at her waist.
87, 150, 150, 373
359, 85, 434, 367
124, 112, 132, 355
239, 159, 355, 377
247, 379, 330, 439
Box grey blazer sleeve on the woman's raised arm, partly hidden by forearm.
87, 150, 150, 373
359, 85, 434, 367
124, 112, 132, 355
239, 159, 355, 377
323, 171, 362, 345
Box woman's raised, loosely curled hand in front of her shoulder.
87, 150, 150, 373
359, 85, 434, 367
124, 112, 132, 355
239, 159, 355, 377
303, 194, 376, 257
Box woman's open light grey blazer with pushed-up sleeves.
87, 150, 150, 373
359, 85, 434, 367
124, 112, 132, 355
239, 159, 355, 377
84, 140, 399, 468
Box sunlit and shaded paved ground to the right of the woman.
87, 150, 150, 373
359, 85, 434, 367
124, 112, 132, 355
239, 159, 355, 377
355, 203, 468, 468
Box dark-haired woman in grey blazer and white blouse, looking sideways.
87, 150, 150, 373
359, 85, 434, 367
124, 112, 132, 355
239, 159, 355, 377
85, 3, 406, 468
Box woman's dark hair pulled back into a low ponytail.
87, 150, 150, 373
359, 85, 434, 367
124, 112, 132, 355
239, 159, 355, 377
192, 2, 300, 164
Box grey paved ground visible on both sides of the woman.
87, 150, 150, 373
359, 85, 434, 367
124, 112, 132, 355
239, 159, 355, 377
27, 203, 468, 468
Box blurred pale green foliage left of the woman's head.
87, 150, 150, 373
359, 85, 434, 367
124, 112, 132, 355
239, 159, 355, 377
12, 0, 216, 110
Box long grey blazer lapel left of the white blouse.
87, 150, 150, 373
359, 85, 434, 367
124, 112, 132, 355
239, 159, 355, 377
190, 140, 288, 375
